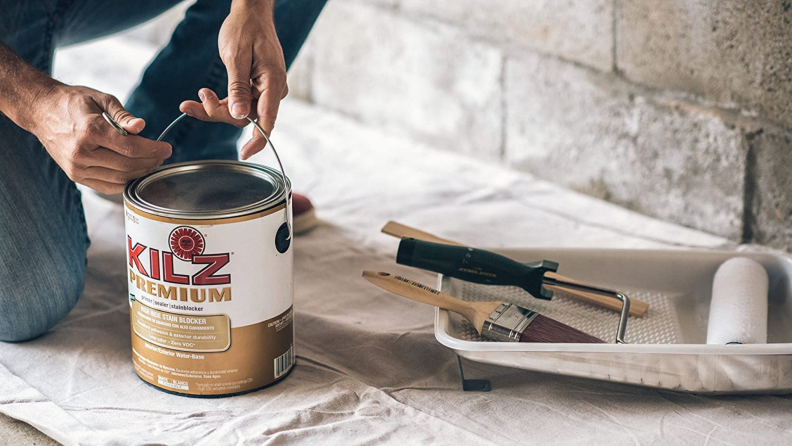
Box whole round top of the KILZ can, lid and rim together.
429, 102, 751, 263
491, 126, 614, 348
124, 160, 288, 219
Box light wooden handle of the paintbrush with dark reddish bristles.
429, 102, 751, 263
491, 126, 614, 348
363, 271, 503, 334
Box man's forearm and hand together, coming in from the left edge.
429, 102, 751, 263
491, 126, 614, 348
0, 44, 171, 193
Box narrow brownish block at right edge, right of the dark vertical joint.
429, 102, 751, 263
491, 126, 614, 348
747, 132, 792, 251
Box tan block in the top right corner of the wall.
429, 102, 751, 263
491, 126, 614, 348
616, 0, 792, 126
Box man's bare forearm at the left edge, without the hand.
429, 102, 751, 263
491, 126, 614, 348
0, 44, 61, 131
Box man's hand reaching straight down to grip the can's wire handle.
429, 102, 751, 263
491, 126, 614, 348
179, 0, 289, 159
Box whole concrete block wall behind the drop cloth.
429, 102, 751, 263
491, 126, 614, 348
290, 0, 792, 250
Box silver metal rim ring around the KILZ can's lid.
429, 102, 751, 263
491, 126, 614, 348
124, 160, 291, 220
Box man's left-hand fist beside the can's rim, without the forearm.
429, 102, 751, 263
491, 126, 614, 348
29, 84, 171, 194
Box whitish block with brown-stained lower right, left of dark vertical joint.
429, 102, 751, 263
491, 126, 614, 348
505, 55, 746, 240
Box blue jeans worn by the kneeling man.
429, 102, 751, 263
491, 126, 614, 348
0, 0, 326, 341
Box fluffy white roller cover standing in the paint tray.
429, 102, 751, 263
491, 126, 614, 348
707, 257, 768, 345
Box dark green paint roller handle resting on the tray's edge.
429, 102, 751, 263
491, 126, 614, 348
396, 238, 558, 300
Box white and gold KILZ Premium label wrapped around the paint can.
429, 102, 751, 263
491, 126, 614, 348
125, 206, 294, 395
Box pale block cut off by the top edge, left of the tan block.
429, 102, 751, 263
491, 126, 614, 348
401, 0, 613, 71
